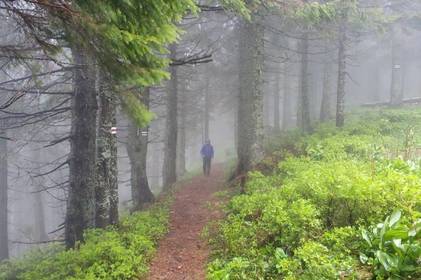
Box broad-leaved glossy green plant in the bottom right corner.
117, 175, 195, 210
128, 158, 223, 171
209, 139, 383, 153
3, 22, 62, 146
360, 211, 421, 279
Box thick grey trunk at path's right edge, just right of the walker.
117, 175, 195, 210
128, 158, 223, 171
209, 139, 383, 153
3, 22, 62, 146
237, 18, 264, 175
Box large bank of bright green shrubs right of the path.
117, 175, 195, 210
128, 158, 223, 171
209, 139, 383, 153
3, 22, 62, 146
207, 109, 421, 280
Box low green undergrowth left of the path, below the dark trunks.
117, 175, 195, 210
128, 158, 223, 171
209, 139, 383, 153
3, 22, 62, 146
0, 199, 170, 280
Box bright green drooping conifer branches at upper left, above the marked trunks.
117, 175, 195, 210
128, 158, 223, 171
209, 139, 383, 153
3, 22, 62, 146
70, 0, 196, 86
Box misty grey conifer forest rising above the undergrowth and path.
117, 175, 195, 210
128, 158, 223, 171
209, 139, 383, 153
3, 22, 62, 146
0, 0, 421, 259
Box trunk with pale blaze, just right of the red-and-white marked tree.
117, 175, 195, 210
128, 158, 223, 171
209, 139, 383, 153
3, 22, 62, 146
127, 88, 154, 210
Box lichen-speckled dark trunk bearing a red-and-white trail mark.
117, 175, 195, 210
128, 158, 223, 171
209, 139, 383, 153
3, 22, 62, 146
95, 69, 118, 228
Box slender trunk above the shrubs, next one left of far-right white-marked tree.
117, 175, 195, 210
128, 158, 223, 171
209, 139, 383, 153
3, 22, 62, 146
336, 16, 347, 127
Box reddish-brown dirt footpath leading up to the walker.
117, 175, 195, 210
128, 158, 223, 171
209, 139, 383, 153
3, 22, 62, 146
147, 165, 224, 280
